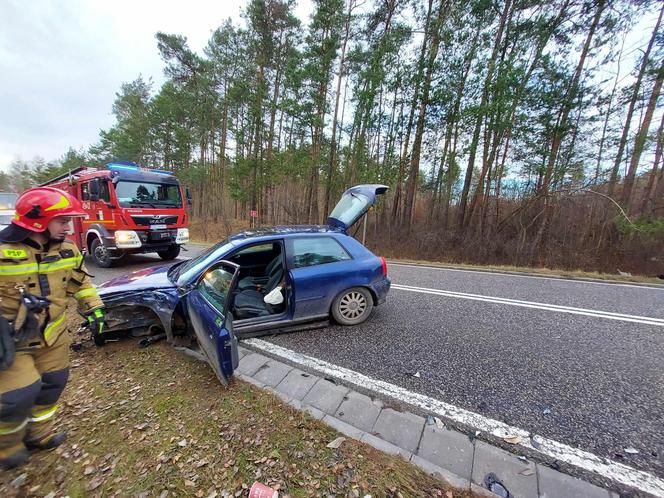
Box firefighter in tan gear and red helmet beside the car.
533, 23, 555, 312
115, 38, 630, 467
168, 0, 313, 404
0, 187, 104, 469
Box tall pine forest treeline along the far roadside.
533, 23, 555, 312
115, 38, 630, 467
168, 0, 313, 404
5, 0, 664, 274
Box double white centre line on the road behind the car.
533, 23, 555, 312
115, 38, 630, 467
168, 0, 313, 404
390, 284, 664, 327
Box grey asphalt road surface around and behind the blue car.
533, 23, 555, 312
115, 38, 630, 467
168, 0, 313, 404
90, 246, 664, 476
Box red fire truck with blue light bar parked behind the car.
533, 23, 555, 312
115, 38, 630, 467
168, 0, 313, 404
42, 162, 191, 268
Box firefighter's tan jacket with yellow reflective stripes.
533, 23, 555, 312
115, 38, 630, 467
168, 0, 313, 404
0, 239, 103, 346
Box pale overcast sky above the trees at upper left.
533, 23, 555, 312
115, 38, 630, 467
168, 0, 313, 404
0, 0, 311, 169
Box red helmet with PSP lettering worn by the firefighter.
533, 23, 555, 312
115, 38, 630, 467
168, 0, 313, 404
12, 187, 86, 232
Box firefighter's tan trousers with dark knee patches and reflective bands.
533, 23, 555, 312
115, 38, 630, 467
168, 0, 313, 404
0, 330, 71, 458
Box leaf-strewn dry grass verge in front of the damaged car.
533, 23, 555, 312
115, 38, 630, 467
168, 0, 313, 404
0, 334, 473, 498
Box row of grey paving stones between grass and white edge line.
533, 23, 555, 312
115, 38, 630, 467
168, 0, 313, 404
236, 347, 619, 498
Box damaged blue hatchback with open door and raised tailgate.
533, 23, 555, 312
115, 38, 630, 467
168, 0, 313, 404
93, 185, 390, 384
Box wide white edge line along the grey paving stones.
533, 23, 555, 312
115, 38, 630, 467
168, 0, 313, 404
243, 339, 664, 497
